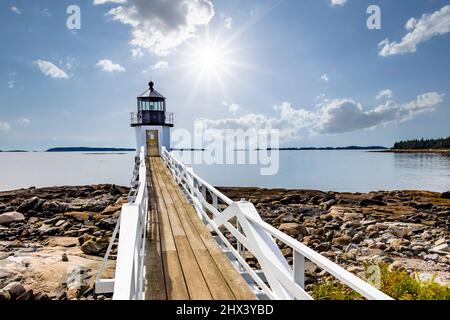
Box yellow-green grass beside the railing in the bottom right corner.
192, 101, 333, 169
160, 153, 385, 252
311, 265, 450, 300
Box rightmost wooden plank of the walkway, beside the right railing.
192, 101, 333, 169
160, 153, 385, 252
157, 158, 256, 300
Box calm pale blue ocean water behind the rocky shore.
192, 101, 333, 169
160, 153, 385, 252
0, 151, 450, 192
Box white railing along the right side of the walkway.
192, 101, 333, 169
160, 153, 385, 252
162, 148, 392, 300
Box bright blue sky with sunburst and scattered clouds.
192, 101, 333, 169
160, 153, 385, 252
0, 0, 450, 150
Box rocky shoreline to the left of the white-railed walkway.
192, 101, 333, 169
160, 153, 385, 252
0, 185, 129, 300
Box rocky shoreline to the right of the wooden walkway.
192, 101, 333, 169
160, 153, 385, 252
219, 188, 450, 286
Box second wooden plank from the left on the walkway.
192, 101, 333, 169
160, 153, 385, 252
149, 159, 190, 300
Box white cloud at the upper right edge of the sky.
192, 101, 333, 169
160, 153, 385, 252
378, 5, 450, 57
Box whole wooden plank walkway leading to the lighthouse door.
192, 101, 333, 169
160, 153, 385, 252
146, 158, 256, 300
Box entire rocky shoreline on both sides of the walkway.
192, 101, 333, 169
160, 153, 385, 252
0, 185, 450, 300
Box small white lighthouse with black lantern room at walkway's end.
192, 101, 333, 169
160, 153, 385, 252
131, 81, 174, 157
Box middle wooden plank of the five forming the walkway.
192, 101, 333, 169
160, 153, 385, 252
150, 158, 212, 300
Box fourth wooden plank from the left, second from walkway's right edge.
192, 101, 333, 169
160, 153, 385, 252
154, 162, 236, 300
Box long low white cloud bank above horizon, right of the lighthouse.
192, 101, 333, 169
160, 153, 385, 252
198, 92, 443, 141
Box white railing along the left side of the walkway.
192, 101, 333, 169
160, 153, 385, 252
95, 148, 148, 300
